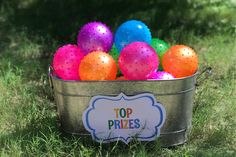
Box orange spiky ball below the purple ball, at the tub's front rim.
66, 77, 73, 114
79, 51, 117, 80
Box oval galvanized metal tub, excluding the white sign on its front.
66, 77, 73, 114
49, 68, 197, 147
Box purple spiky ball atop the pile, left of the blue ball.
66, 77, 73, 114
77, 22, 113, 55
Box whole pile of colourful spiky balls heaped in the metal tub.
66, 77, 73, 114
52, 20, 198, 81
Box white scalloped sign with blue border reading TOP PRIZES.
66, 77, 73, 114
83, 93, 165, 144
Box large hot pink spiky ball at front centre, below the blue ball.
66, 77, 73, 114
118, 42, 159, 80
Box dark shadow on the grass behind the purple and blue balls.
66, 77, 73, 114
5, 0, 188, 41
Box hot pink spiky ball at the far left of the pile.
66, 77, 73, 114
53, 44, 84, 80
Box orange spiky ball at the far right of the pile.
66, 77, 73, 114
162, 45, 198, 78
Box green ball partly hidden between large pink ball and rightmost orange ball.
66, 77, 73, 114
151, 38, 170, 70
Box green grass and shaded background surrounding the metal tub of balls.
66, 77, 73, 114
0, 0, 236, 157
